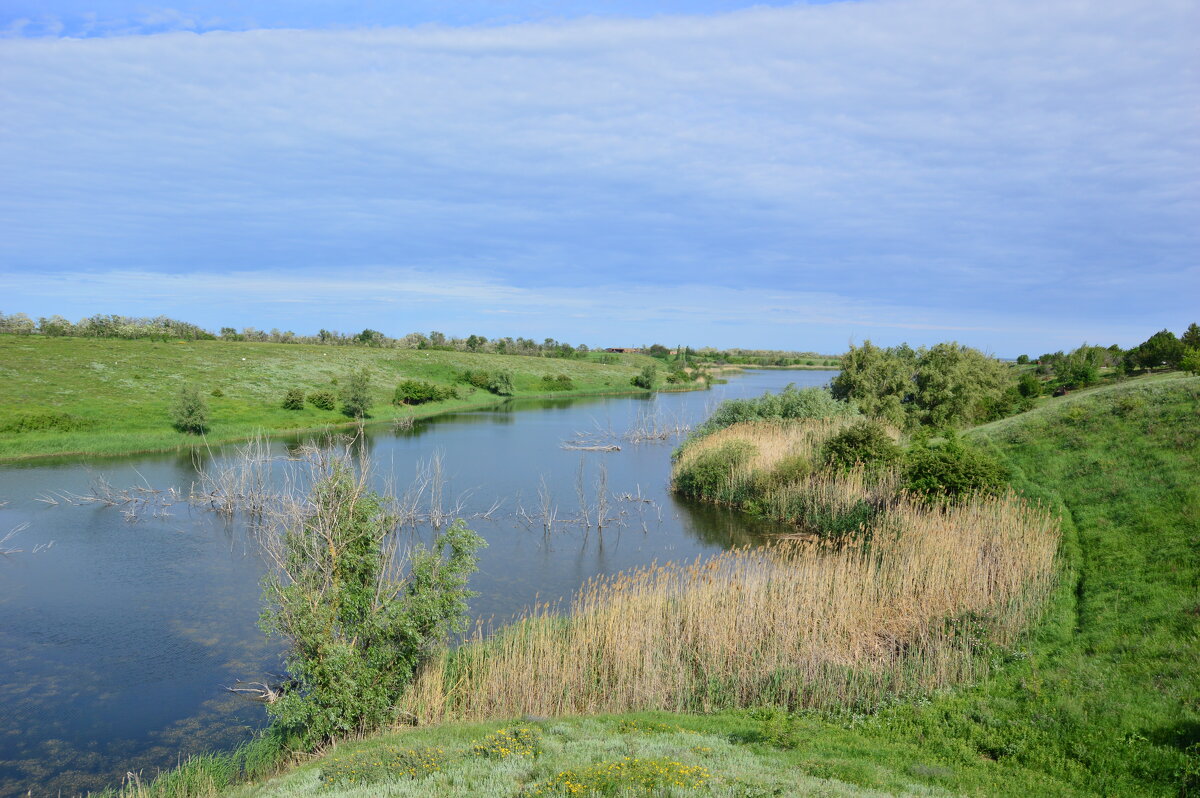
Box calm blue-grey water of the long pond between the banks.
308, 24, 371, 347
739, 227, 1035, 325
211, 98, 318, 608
0, 371, 834, 798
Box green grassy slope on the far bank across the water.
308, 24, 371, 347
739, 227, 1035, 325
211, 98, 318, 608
0, 335, 676, 461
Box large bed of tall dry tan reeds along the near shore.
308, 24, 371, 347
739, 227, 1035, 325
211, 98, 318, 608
398, 496, 1058, 724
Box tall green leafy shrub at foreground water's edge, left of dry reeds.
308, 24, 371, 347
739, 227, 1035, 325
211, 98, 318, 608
263, 462, 485, 748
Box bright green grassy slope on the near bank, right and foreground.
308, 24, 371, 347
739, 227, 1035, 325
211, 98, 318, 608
152, 377, 1200, 798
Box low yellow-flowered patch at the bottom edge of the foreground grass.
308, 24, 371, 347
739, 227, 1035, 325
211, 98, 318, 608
526, 756, 713, 796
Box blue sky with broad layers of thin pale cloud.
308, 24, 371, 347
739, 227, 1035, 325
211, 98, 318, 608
0, 0, 1200, 356
